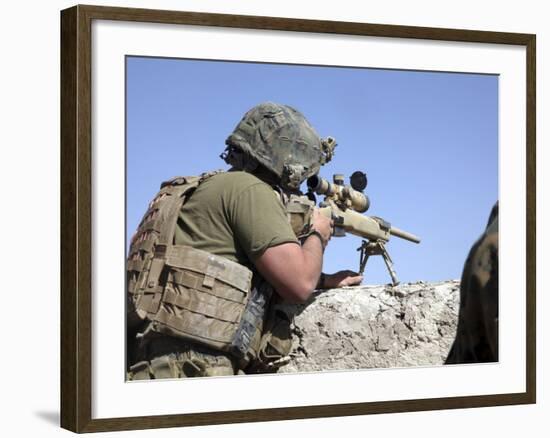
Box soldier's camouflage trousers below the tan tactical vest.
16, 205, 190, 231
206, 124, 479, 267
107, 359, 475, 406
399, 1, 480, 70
127, 337, 243, 380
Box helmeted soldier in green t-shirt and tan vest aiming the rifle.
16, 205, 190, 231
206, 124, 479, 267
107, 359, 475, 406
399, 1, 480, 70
127, 102, 362, 380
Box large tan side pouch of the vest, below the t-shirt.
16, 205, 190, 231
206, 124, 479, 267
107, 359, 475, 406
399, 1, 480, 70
151, 245, 252, 351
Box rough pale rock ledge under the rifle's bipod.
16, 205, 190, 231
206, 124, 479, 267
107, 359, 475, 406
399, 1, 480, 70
279, 280, 460, 373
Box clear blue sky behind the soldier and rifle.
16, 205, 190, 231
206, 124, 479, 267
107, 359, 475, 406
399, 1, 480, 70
126, 57, 498, 284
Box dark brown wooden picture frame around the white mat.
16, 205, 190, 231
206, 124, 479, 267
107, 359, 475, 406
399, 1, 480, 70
61, 6, 536, 432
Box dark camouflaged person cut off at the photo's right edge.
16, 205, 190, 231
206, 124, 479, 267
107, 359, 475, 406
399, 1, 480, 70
445, 202, 498, 364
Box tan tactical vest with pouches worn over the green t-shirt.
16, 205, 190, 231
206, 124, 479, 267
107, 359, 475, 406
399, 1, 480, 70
127, 171, 312, 371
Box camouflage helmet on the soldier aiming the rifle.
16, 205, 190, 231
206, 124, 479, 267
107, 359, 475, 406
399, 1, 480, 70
222, 102, 336, 190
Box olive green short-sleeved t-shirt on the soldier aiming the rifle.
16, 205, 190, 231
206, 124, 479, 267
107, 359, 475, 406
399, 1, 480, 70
174, 171, 298, 268
